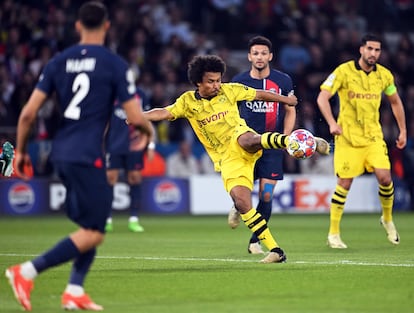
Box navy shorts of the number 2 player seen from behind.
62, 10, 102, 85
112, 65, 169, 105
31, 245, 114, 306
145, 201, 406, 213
55, 162, 113, 233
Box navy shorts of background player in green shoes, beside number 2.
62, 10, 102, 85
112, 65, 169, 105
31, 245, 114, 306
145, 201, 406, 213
106, 151, 144, 171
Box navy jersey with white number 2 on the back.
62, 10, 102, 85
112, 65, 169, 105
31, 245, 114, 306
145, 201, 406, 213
36, 45, 136, 165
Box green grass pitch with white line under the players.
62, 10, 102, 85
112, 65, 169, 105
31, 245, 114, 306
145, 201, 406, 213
0, 213, 414, 313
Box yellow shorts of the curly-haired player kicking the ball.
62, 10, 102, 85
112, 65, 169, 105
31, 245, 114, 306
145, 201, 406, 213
221, 126, 262, 192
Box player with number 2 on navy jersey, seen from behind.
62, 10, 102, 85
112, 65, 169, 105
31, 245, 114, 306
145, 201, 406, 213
6, 1, 152, 311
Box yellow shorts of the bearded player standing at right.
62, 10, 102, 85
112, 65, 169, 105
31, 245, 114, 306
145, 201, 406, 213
334, 136, 391, 178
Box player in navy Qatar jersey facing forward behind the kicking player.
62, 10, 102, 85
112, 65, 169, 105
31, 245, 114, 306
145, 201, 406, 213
228, 36, 296, 254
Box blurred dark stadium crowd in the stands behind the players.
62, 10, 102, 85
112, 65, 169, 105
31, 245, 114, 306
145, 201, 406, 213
0, 0, 414, 197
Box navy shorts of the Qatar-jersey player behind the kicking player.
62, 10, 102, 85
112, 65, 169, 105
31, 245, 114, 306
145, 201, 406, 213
254, 149, 284, 180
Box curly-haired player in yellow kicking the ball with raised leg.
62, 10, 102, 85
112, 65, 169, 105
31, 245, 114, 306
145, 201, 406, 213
145, 55, 329, 263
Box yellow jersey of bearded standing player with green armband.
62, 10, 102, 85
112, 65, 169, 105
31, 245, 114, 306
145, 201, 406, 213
320, 61, 397, 147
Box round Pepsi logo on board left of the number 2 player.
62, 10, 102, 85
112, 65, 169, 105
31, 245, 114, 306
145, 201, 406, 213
8, 182, 35, 213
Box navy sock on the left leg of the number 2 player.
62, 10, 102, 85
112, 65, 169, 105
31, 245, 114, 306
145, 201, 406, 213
32, 237, 79, 273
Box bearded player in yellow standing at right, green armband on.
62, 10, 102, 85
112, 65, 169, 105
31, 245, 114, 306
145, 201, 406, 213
317, 34, 407, 249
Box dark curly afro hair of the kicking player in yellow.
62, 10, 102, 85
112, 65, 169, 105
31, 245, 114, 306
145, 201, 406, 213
187, 55, 226, 86
